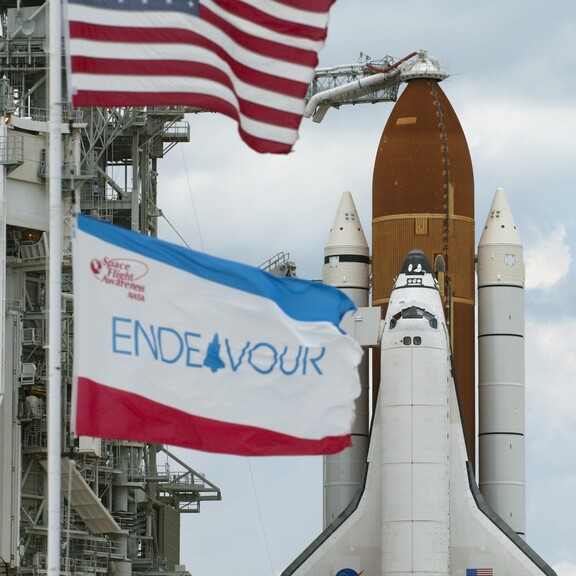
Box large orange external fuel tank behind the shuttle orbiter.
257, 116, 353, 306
372, 78, 475, 463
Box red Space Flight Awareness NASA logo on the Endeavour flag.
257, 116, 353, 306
90, 256, 148, 302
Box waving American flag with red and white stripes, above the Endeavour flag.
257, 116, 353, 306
68, 0, 335, 153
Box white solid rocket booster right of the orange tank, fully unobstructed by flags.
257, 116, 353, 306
478, 188, 526, 536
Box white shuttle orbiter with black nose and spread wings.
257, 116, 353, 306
283, 250, 555, 576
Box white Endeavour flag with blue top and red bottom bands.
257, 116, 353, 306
73, 216, 362, 455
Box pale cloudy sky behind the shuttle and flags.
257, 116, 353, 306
151, 0, 576, 576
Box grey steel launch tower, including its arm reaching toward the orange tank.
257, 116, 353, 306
0, 0, 426, 576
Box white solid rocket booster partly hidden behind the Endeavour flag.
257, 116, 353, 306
322, 192, 370, 527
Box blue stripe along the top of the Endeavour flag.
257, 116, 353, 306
77, 214, 355, 325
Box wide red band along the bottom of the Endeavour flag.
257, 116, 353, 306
75, 377, 351, 456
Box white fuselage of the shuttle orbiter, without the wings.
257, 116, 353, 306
378, 258, 450, 575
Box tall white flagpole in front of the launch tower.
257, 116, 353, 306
47, 0, 62, 576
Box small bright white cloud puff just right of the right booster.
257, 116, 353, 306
524, 224, 572, 289
